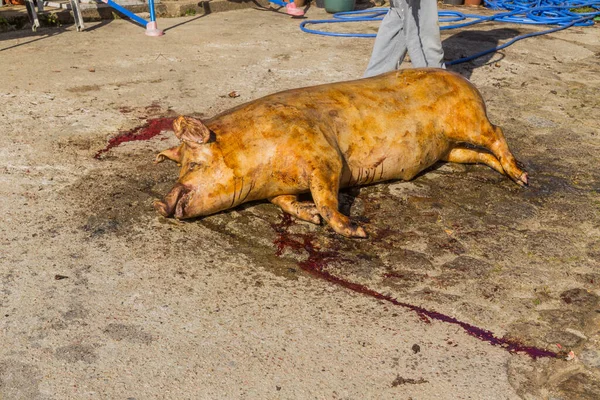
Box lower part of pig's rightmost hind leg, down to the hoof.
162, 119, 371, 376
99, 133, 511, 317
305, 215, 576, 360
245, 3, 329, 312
469, 124, 529, 186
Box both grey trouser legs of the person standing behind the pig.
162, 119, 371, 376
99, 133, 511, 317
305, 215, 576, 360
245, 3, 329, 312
364, 0, 444, 77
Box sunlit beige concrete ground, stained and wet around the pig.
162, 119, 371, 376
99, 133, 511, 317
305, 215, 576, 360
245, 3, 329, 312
0, 4, 600, 400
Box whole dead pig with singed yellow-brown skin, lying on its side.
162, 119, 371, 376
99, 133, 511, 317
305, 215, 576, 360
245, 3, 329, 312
155, 68, 527, 237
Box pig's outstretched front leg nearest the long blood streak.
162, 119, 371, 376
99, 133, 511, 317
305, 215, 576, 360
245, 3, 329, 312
310, 166, 367, 238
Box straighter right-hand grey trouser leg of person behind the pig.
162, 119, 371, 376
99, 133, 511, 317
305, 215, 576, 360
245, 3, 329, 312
401, 0, 445, 68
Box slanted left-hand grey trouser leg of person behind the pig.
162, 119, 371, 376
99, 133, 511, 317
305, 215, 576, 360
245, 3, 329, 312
364, 0, 406, 78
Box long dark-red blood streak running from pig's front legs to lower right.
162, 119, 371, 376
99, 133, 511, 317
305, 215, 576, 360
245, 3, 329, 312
272, 214, 559, 359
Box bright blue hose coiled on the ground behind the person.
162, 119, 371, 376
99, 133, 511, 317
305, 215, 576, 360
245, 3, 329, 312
300, 0, 600, 65
